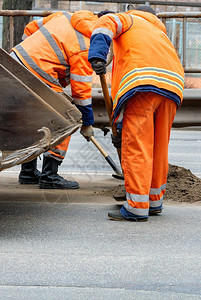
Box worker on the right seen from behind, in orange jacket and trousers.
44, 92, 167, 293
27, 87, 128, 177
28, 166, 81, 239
89, 6, 184, 221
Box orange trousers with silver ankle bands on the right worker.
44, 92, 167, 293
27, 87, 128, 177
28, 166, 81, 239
121, 92, 177, 218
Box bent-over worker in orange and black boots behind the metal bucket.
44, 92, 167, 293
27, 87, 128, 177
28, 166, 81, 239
11, 11, 98, 189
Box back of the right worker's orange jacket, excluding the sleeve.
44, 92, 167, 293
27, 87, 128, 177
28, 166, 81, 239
112, 10, 184, 102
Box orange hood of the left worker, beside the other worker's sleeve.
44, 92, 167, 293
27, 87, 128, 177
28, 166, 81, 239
71, 10, 98, 38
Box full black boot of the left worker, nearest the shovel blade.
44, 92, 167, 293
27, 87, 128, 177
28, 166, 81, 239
39, 156, 79, 189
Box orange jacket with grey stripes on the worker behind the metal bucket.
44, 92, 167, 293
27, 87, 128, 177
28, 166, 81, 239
12, 11, 97, 125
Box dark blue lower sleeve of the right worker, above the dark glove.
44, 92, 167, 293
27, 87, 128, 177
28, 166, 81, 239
88, 33, 112, 63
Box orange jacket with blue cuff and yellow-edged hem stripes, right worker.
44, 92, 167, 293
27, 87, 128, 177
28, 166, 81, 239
89, 10, 184, 113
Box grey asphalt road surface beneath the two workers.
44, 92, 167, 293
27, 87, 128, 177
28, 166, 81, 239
0, 130, 201, 300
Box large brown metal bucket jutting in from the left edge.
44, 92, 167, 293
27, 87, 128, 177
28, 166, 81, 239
0, 49, 82, 171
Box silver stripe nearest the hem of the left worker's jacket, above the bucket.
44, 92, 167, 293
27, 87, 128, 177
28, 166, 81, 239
15, 44, 61, 86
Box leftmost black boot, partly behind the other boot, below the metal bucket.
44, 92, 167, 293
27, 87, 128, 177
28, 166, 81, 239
19, 158, 41, 184
